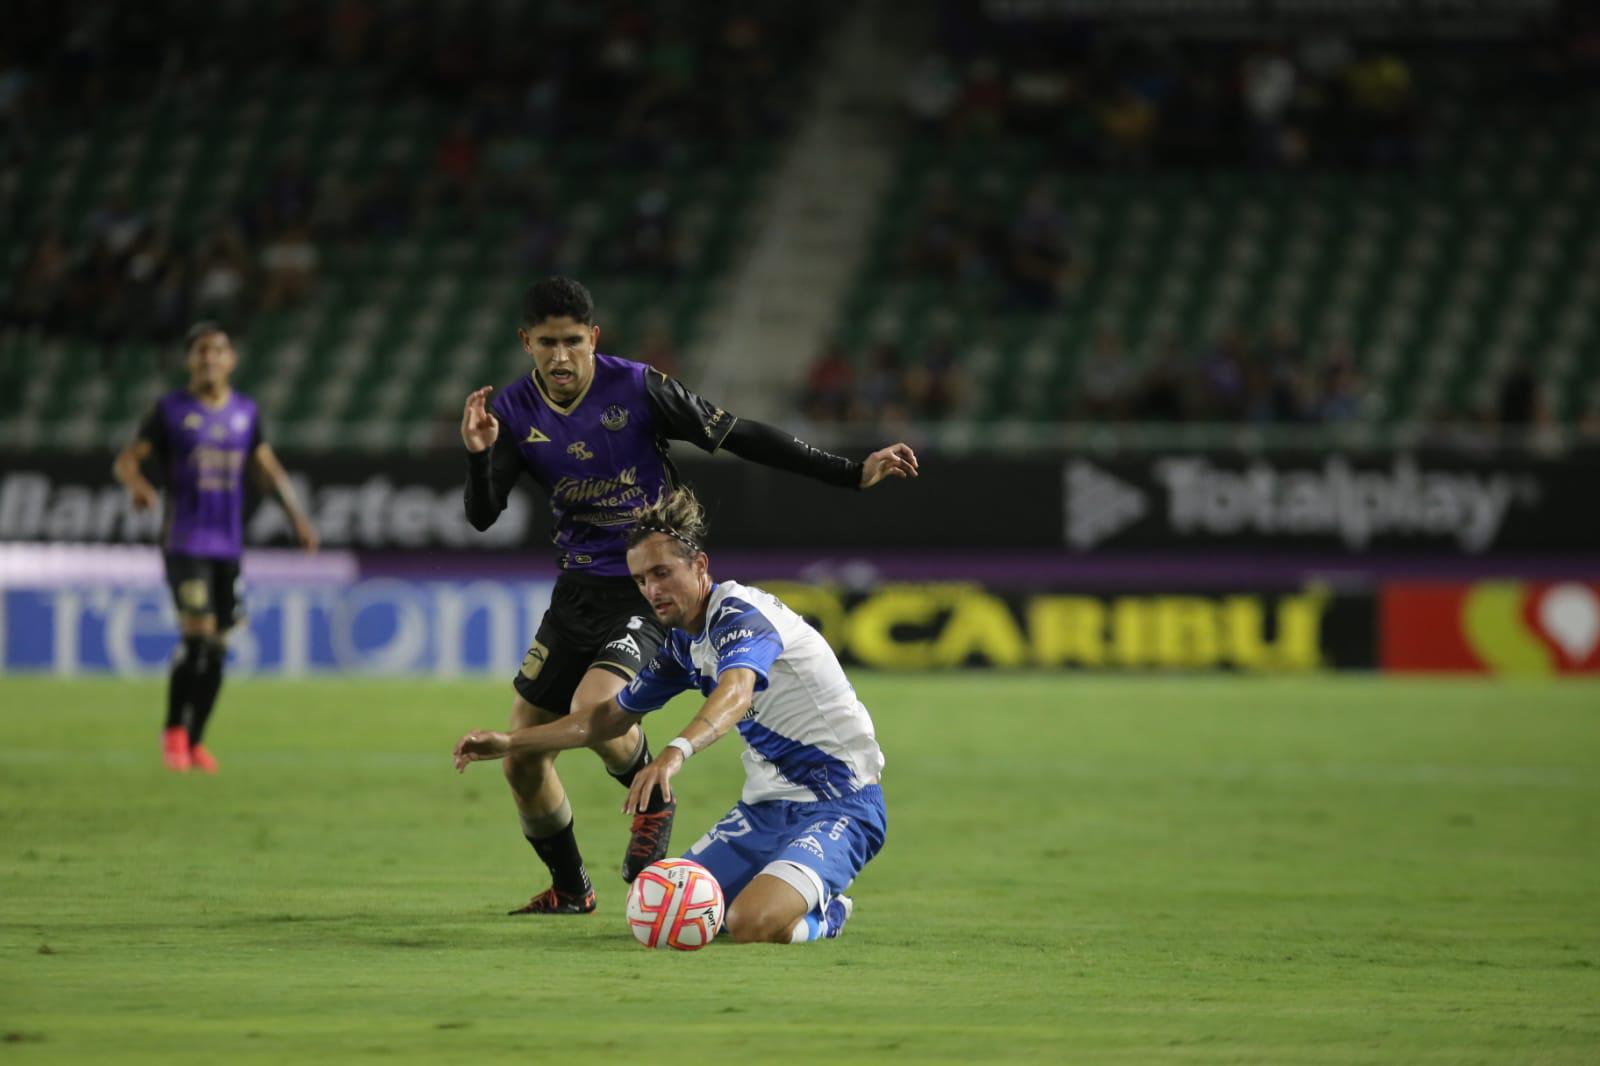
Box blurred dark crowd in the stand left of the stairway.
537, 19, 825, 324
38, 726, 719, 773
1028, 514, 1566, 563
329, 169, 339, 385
0, 0, 830, 351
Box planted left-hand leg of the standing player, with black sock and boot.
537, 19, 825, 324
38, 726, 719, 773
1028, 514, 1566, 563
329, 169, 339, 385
501, 696, 595, 914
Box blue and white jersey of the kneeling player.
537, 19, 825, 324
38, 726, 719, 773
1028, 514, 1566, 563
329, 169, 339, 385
618, 581, 883, 804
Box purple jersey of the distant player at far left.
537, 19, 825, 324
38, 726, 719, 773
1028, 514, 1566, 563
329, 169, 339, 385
139, 389, 261, 559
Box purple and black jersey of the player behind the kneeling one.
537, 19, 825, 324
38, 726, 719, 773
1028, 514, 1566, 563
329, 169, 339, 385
467, 354, 736, 576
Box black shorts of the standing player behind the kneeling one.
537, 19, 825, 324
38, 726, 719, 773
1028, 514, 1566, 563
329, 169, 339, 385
512, 573, 667, 714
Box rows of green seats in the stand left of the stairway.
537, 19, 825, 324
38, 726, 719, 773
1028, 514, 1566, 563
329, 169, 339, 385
0, 17, 781, 447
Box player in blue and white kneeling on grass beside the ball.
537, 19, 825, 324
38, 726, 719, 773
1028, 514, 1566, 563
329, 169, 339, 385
454, 488, 885, 943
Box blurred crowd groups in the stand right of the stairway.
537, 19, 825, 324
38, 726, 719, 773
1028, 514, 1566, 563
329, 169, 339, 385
800, 0, 1600, 440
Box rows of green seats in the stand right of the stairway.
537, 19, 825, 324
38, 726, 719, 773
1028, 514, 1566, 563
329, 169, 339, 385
838, 94, 1600, 424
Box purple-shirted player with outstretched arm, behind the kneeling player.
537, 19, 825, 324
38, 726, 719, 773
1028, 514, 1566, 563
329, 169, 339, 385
461, 277, 917, 914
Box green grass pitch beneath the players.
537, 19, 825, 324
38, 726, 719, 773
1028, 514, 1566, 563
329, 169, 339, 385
0, 674, 1600, 1063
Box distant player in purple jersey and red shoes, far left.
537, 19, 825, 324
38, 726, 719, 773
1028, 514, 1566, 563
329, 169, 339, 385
112, 322, 317, 773
